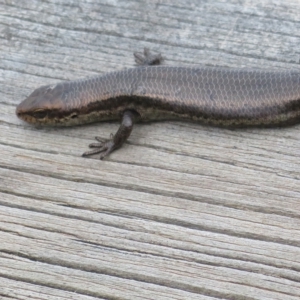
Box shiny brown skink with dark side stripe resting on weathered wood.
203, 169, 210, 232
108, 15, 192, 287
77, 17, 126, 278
16, 49, 300, 159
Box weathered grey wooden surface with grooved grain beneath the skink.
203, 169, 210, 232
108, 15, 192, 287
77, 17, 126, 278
0, 0, 300, 300
